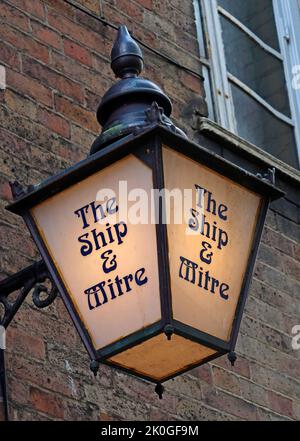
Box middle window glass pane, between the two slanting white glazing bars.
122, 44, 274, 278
220, 16, 290, 116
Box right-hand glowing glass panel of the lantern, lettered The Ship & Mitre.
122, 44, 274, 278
163, 147, 261, 342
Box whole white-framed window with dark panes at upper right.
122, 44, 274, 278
194, 0, 300, 168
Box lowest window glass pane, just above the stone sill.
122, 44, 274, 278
231, 84, 298, 168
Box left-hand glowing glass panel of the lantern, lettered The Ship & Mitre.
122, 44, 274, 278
31, 155, 161, 350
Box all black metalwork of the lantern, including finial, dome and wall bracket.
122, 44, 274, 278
0, 26, 284, 409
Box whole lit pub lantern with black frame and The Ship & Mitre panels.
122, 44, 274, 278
0, 26, 282, 397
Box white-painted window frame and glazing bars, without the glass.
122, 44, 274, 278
194, 0, 300, 167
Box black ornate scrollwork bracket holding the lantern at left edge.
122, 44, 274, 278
0, 260, 57, 328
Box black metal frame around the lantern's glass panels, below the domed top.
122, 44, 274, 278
0, 123, 283, 392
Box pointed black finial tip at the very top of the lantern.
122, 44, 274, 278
111, 25, 144, 78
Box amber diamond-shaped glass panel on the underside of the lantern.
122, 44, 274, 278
107, 334, 216, 382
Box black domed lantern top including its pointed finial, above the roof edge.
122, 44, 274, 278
91, 25, 178, 154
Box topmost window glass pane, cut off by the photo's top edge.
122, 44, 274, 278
218, 0, 278, 51
